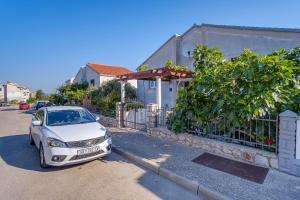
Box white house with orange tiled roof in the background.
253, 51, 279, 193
73, 63, 137, 88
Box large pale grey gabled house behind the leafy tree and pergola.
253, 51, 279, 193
137, 24, 300, 107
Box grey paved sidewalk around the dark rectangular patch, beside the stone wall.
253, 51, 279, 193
110, 128, 300, 200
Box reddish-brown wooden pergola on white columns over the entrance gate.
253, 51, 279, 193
117, 67, 193, 108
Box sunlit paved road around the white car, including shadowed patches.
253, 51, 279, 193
0, 108, 198, 200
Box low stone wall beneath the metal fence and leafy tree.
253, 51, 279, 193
149, 128, 278, 169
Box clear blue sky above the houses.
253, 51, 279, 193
0, 0, 300, 92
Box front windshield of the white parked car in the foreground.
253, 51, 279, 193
47, 109, 96, 126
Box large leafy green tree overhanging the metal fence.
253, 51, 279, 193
170, 45, 300, 132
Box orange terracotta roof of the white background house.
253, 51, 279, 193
87, 63, 132, 76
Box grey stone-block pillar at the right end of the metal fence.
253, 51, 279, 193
278, 110, 300, 176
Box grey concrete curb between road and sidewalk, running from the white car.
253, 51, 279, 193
112, 145, 230, 200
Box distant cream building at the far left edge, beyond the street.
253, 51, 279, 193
2, 81, 31, 102
